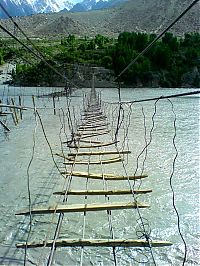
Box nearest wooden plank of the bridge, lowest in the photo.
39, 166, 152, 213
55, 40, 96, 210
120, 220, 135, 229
16, 239, 173, 248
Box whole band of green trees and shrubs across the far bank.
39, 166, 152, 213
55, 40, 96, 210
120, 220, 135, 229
0, 32, 200, 87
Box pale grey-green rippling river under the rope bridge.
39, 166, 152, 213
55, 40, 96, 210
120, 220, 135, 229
0, 85, 200, 266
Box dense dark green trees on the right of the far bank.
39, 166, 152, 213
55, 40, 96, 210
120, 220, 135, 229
113, 32, 200, 87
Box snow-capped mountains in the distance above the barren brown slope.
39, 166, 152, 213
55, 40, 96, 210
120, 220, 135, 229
0, 0, 128, 18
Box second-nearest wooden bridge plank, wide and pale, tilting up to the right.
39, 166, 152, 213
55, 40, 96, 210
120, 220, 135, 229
16, 202, 150, 215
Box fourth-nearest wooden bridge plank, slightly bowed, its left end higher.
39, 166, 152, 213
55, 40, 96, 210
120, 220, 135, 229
61, 171, 148, 180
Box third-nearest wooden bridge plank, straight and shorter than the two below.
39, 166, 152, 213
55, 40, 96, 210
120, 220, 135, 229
53, 189, 152, 196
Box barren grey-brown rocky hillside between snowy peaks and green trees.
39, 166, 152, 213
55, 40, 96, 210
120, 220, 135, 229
0, 0, 200, 37
